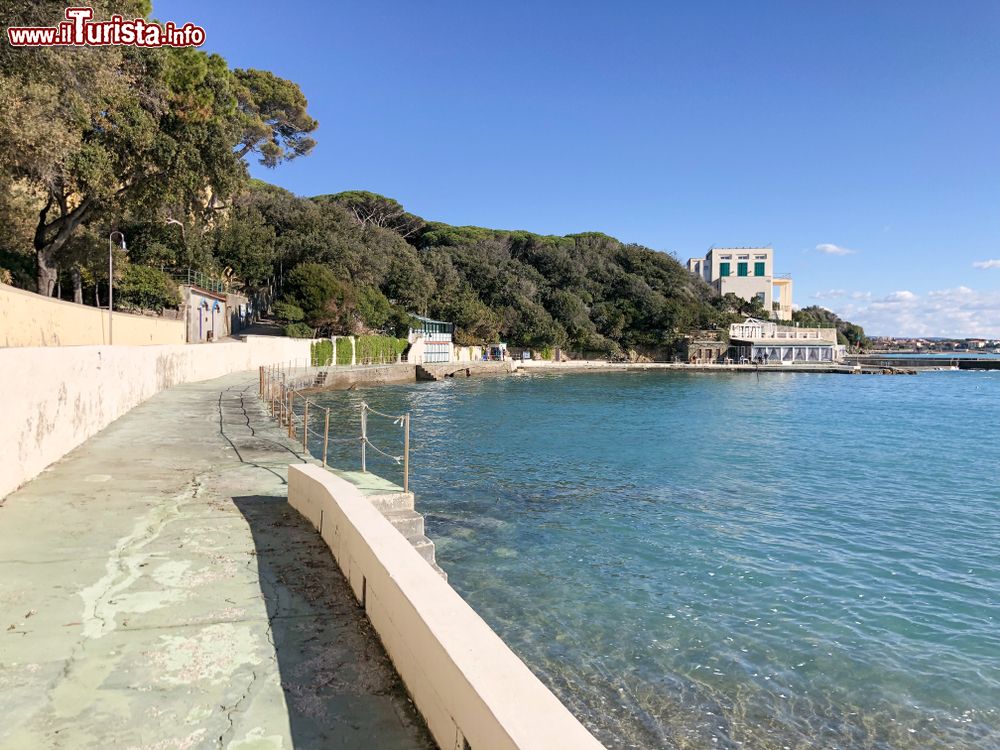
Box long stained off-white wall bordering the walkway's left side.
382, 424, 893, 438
0, 336, 311, 497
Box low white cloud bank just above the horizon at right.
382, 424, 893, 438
836, 286, 1000, 338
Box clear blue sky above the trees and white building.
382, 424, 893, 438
154, 0, 1000, 337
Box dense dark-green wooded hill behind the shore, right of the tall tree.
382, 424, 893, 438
234, 183, 741, 354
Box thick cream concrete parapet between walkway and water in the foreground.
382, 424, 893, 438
288, 464, 602, 750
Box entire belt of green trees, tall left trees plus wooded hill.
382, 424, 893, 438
0, 0, 863, 355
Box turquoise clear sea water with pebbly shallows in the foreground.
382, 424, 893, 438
308, 372, 1000, 748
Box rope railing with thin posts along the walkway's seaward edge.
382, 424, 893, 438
259, 362, 410, 492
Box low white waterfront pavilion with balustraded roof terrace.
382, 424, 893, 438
729, 318, 846, 364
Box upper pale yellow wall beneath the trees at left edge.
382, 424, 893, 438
0, 284, 187, 346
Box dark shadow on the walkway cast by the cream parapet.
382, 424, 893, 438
233, 495, 436, 748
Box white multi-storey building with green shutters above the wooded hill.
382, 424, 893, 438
688, 247, 792, 320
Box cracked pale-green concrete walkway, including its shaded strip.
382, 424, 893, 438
0, 373, 433, 750
